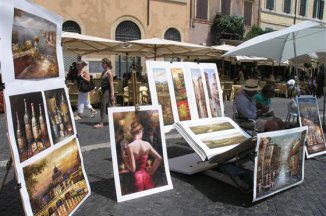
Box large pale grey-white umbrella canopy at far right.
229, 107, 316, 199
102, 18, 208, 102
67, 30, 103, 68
224, 21, 326, 62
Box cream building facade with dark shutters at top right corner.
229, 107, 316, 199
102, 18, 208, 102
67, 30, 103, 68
260, 0, 326, 30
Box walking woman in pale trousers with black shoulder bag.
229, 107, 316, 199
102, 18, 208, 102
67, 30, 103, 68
75, 61, 97, 120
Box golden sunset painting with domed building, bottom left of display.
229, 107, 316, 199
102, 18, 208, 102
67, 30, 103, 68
23, 139, 89, 215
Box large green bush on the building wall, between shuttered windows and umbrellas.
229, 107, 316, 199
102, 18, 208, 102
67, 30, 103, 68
211, 13, 244, 44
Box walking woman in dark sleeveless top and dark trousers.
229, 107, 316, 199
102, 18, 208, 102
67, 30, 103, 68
93, 58, 115, 128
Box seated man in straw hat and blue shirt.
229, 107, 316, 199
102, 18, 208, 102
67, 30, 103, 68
234, 79, 283, 132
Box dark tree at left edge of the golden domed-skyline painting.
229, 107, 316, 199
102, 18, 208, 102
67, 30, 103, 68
24, 160, 47, 197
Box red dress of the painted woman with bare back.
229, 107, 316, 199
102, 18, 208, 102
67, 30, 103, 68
134, 155, 154, 192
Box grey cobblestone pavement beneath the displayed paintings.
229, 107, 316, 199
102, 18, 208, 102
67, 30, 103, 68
0, 98, 326, 216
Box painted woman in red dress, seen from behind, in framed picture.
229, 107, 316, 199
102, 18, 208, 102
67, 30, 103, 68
122, 121, 162, 192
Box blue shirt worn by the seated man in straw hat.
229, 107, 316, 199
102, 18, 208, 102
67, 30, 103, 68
234, 90, 257, 119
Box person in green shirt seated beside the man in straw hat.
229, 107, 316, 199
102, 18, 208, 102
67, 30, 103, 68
254, 84, 275, 116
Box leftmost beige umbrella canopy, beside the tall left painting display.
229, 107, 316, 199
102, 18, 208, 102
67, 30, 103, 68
61, 32, 123, 55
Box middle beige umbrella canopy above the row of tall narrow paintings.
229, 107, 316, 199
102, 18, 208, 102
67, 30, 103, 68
114, 38, 207, 59
